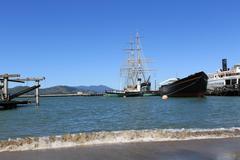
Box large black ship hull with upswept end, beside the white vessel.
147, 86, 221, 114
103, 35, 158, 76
159, 72, 208, 97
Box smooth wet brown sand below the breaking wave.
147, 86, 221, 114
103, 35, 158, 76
0, 138, 240, 160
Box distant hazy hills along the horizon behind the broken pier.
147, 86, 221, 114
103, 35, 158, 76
9, 85, 112, 95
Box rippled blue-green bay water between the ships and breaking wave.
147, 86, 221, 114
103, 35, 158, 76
0, 97, 240, 139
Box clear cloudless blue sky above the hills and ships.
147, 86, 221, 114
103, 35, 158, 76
0, 0, 240, 88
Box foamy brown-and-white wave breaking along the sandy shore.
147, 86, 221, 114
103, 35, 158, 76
0, 127, 240, 152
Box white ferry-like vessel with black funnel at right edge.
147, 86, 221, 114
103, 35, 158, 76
207, 59, 240, 96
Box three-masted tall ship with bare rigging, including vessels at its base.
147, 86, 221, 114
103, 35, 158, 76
105, 33, 155, 97
